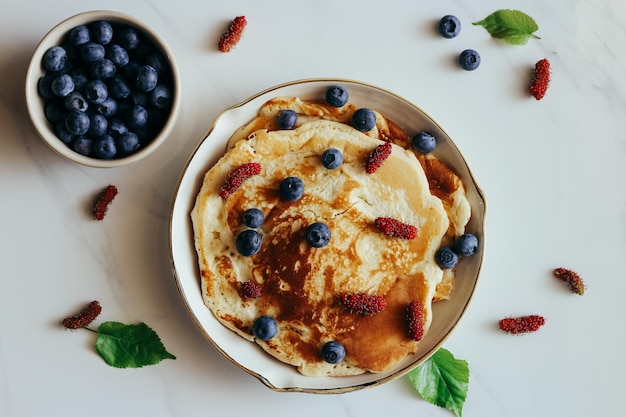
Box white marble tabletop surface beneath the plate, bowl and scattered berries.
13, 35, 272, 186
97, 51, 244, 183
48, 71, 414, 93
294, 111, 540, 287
0, 0, 626, 417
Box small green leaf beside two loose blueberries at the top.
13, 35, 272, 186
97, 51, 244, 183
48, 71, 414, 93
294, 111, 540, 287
472, 9, 539, 45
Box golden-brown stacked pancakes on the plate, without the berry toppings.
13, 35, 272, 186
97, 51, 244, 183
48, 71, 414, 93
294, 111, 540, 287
191, 97, 470, 376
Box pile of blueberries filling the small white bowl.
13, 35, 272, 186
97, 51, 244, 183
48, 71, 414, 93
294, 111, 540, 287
37, 20, 174, 159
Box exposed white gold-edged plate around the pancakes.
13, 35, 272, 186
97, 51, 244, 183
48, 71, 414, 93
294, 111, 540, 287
170, 79, 486, 393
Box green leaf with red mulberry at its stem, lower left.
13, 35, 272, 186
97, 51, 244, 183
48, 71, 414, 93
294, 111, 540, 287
96, 321, 176, 368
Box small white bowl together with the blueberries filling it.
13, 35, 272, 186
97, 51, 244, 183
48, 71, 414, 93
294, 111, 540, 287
25, 11, 180, 168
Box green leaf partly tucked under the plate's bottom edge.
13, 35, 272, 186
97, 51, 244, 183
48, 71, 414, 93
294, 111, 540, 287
408, 348, 469, 417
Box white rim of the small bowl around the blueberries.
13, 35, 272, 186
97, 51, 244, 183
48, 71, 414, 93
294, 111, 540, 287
25, 10, 181, 168
